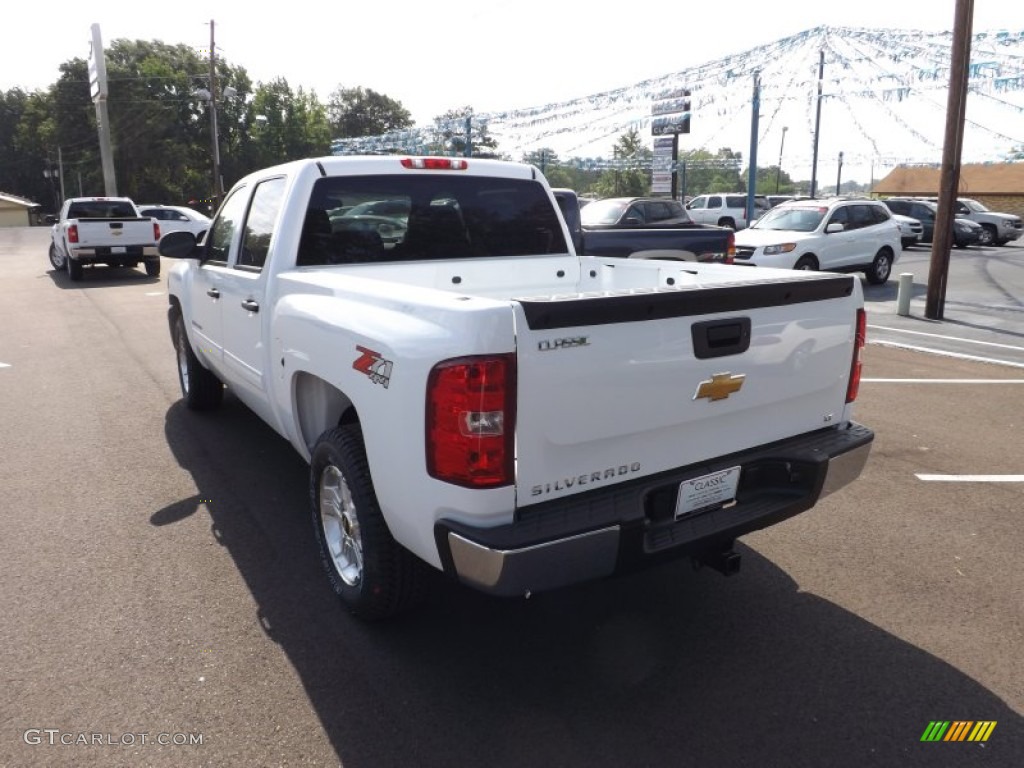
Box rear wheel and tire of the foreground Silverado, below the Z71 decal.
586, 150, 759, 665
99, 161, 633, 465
309, 424, 426, 620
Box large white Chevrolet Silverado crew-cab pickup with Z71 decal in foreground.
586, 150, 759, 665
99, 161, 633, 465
160, 157, 873, 618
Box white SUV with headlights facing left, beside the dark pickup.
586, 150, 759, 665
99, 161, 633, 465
735, 198, 902, 285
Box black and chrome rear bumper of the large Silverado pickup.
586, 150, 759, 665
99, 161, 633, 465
434, 424, 874, 596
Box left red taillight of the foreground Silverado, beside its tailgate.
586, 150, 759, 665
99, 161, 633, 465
427, 354, 515, 488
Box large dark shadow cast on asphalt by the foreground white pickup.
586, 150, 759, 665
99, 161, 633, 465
152, 396, 1024, 768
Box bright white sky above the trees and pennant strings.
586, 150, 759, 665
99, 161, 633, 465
8, 0, 1024, 124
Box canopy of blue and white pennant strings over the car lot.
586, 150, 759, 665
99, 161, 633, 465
332, 27, 1024, 173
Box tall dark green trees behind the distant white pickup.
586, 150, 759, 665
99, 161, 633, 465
0, 40, 331, 211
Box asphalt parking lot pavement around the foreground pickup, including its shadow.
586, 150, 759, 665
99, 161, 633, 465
0, 228, 1024, 768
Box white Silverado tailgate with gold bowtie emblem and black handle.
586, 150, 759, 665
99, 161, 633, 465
516, 274, 860, 506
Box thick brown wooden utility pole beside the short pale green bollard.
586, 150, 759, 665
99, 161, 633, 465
925, 0, 974, 319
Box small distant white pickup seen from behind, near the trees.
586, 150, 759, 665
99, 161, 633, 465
49, 198, 160, 281
